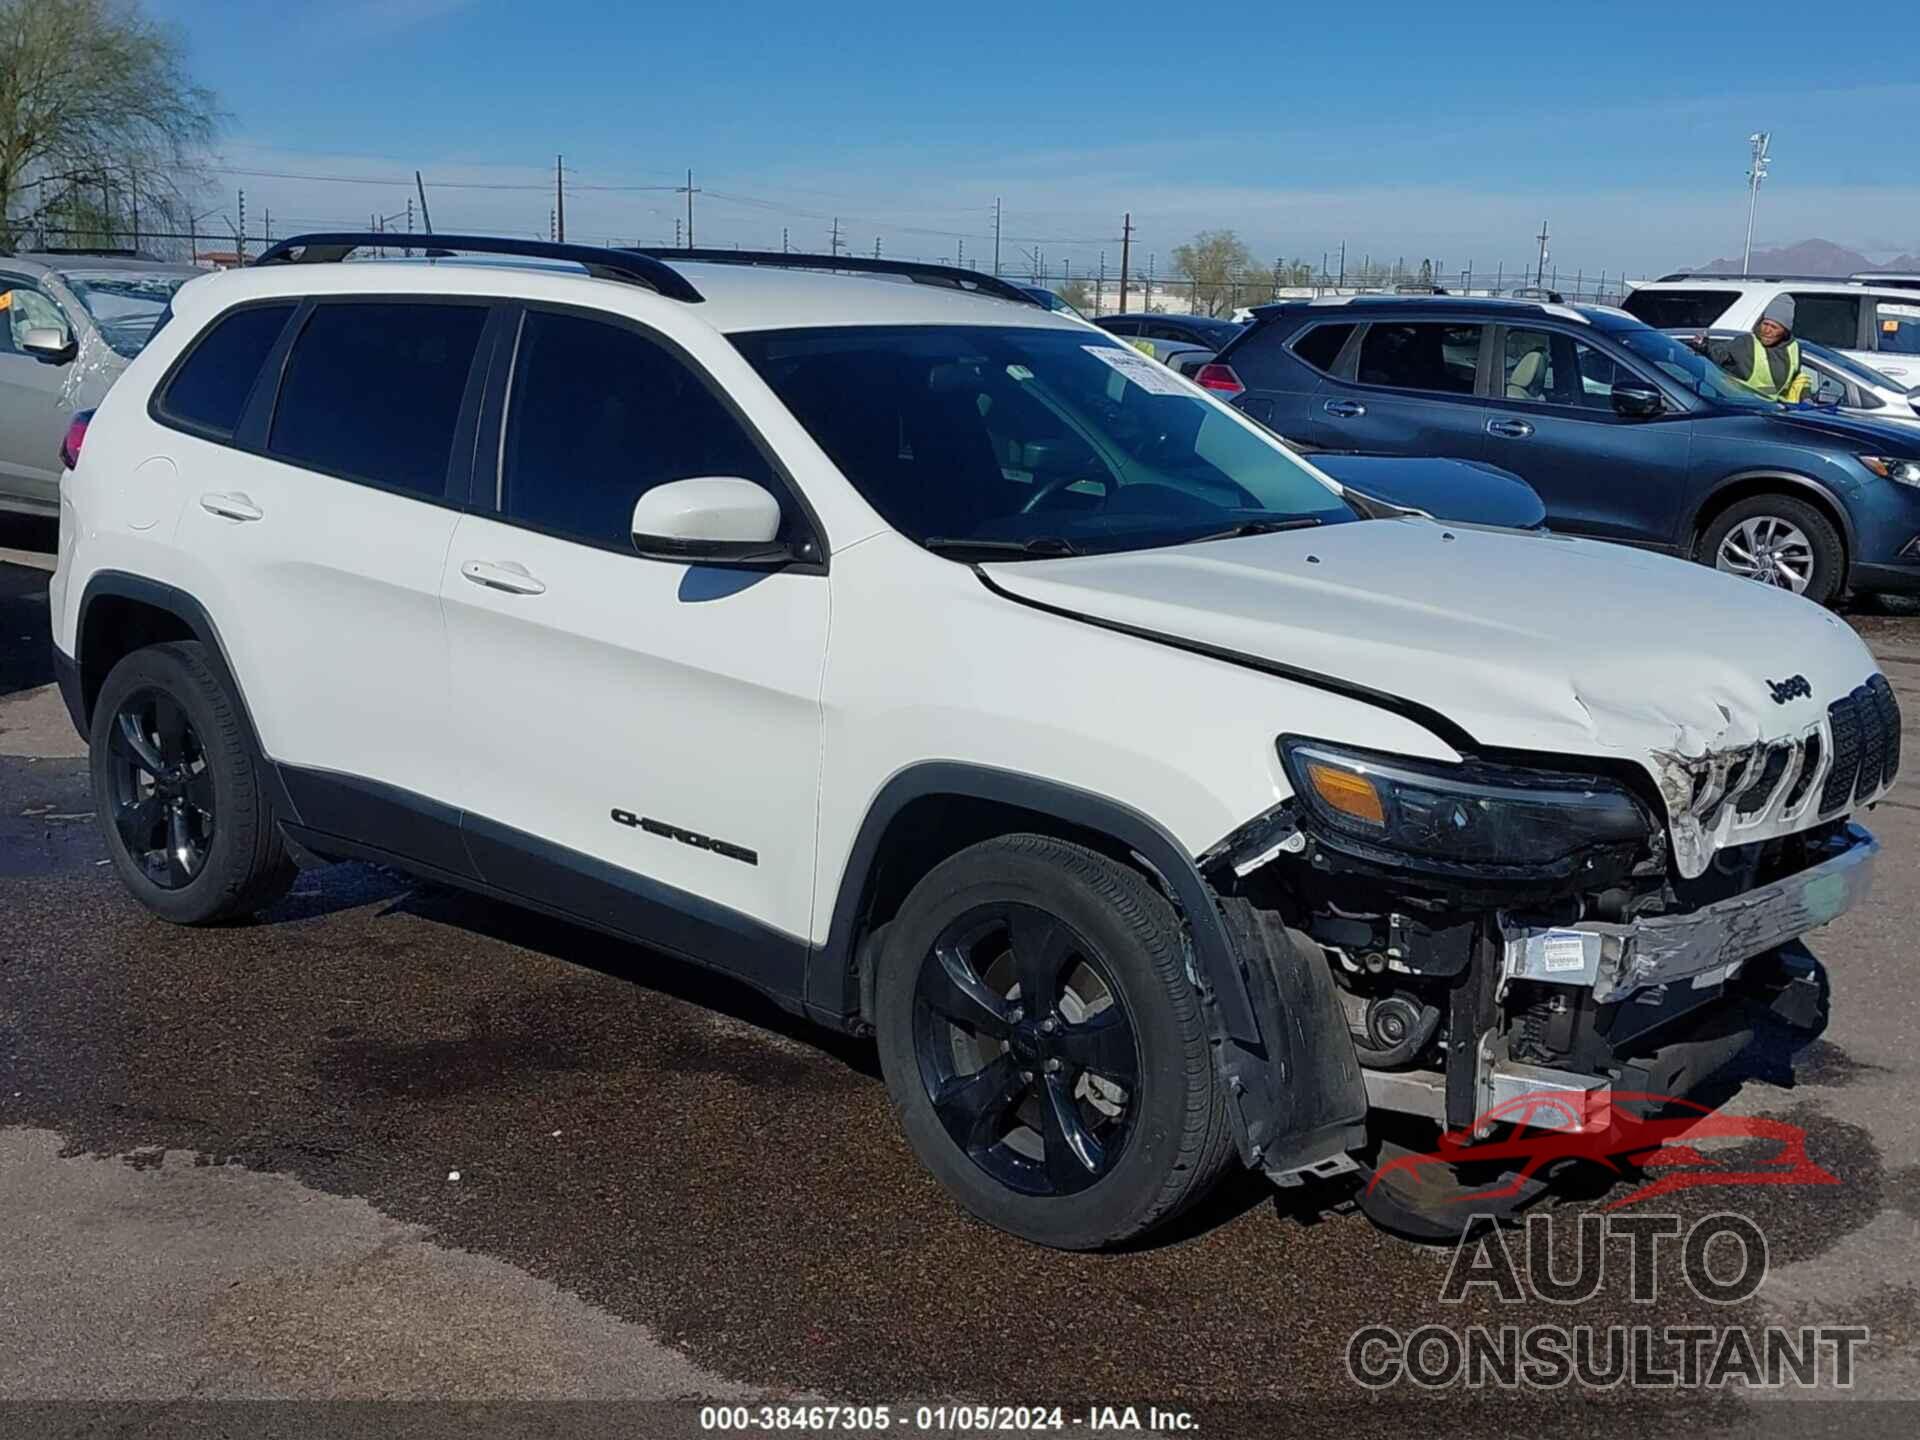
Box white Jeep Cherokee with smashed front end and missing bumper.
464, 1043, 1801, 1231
52, 236, 1899, 1246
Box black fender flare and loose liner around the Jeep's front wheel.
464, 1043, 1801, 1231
806, 760, 1367, 1177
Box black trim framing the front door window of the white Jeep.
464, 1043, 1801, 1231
470, 300, 831, 576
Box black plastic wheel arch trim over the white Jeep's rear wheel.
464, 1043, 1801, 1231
69, 570, 300, 824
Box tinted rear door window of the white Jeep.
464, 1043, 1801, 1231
267, 301, 486, 495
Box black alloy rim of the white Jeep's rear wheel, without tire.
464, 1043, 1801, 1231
108, 689, 217, 891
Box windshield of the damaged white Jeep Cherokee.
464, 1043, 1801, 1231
733, 324, 1356, 555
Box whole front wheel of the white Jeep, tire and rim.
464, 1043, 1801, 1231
874, 835, 1233, 1250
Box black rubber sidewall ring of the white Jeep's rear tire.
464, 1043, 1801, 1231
88, 647, 252, 924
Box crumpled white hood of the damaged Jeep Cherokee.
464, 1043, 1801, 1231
985, 518, 1878, 783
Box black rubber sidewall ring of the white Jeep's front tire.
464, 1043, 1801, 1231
874, 852, 1187, 1250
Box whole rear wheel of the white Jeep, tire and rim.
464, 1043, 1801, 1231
88, 641, 296, 925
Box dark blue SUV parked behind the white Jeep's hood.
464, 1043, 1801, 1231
1198, 296, 1920, 601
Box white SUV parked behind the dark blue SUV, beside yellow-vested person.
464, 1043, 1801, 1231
1620, 271, 1920, 390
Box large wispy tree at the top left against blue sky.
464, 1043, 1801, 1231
0, 0, 221, 244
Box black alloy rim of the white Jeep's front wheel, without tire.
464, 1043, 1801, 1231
914, 900, 1140, 1196
